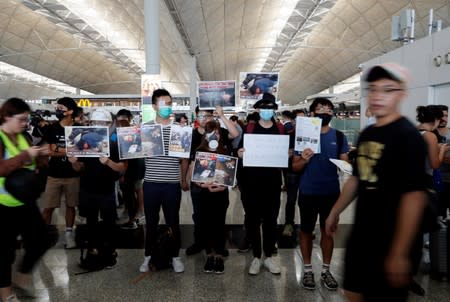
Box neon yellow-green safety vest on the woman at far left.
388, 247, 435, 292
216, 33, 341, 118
0, 130, 35, 207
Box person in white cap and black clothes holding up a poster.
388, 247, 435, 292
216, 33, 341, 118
69, 109, 128, 269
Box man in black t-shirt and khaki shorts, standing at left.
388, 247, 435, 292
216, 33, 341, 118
43, 97, 80, 249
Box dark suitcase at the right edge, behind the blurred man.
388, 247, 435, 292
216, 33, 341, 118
430, 219, 450, 279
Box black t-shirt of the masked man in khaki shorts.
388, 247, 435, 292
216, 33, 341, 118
46, 123, 79, 178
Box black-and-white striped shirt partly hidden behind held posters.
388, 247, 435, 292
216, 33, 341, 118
144, 121, 180, 183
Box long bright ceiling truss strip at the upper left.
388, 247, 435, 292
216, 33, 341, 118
21, 0, 144, 77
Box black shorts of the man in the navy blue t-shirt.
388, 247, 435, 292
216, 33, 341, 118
298, 193, 339, 233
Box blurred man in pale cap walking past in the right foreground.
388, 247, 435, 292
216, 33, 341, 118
326, 63, 427, 301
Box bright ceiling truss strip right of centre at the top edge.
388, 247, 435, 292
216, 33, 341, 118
263, 0, 337, 71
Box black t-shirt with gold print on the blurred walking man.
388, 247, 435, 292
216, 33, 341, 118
349, 117, 426, 259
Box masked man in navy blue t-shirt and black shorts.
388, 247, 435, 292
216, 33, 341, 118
292, 98, 349, 290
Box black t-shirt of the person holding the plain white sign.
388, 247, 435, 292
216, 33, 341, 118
237, 122, 281, 187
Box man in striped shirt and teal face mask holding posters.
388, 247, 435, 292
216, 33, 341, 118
139, 89, 189, 273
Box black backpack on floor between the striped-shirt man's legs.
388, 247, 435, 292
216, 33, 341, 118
149, 225, 176, 271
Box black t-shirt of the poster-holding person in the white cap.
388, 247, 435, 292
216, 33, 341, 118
78, 141, 123, 193
